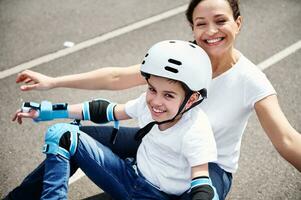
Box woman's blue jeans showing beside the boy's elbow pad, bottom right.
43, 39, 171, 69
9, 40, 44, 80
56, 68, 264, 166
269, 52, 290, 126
180, 163, 232, 200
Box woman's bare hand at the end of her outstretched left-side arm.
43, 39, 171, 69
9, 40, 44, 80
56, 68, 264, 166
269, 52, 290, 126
16, 70, 55, 91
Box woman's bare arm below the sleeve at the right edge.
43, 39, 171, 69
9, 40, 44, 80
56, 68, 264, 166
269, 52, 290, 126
255, 95, 301, 172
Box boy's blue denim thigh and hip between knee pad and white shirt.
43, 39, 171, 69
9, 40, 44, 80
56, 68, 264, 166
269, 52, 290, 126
73, 133, 169, 200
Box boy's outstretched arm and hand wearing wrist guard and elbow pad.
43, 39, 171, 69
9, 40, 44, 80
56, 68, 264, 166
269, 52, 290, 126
12, 99, 130, 124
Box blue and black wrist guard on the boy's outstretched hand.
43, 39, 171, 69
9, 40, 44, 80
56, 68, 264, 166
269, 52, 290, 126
21, 101, 68, 122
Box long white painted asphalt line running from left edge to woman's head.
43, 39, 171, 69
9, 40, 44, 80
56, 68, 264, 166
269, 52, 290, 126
0, 4, 188, 79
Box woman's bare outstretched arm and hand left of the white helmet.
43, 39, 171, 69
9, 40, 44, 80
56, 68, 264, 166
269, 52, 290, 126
16, 65, 146, 91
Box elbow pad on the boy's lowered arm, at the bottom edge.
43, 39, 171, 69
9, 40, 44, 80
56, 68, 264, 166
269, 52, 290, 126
190, 176, 219, 200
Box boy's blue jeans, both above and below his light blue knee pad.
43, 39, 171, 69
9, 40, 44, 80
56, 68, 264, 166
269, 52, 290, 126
41, 130, 177, 200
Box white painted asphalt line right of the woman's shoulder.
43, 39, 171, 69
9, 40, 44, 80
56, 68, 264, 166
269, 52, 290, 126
257, 40, 301, 70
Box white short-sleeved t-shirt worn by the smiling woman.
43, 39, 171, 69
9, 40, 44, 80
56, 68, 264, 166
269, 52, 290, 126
199, 54, 276, 173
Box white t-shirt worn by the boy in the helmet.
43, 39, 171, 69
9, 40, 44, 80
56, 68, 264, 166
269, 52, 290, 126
125, 93, 217, 195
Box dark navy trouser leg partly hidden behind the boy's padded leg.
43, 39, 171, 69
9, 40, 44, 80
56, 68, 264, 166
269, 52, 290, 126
7, 126, 139, 200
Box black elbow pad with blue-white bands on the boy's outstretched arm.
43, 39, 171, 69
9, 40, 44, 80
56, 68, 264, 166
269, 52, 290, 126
82, 99, 119, 144
